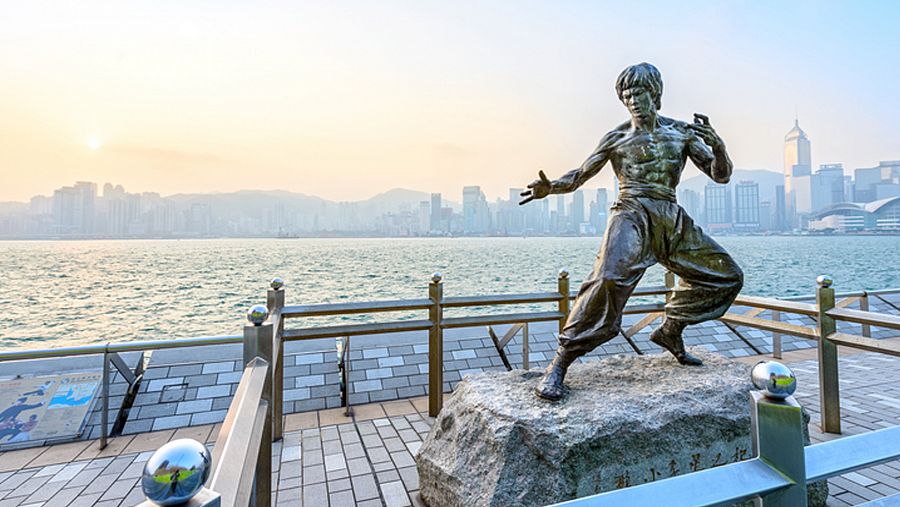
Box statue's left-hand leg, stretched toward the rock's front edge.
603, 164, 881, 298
536, 205, 656, 400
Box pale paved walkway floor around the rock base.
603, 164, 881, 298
0, 351, 900, 507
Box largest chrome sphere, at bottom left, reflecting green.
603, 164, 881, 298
141, 438, 212, 505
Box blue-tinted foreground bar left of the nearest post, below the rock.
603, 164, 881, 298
555, 458, 793, 507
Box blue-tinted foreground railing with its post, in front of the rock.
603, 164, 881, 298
555, 391, 900, 507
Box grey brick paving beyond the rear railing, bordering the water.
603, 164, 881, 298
107, 294, 900, 438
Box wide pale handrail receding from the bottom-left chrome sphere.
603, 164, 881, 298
210, 357, 269, 506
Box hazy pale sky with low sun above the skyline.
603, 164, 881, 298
0, 0, 900, 201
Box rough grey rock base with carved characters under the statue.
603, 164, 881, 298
416, 349, 827, 507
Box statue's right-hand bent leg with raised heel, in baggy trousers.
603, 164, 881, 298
651, 208, 744, 364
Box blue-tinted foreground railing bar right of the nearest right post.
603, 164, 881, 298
805, 426, 900, 482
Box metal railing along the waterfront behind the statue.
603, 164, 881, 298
0, 271, 900, 447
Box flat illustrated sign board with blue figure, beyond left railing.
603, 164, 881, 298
0, 371, 100, 449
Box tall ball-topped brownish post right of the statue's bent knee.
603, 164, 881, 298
816, 275, 841, 433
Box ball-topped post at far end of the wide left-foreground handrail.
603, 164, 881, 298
244, 314, 273, 507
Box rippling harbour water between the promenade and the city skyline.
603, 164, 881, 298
0, 236, 900, 350
